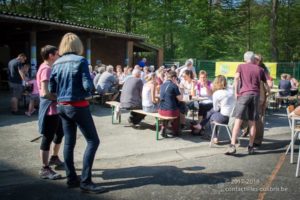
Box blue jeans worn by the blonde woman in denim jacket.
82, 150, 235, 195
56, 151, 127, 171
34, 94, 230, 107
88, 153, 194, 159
58, 105, 100, 184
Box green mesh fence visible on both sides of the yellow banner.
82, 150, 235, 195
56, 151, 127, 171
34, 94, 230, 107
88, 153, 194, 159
168, 59, 300, 80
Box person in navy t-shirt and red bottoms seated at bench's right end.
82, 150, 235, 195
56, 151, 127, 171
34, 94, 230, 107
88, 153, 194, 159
158, 71, 182, 137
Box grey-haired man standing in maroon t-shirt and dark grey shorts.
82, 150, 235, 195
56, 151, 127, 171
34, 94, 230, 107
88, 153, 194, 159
225, 51, 266, 155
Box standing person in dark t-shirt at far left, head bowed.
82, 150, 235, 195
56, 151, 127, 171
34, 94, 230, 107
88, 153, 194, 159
8, 53, 27, 115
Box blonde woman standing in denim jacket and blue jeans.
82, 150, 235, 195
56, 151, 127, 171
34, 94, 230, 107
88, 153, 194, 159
49, 33, 106, 193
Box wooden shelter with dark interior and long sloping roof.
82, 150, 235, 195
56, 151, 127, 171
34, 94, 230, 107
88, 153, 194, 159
0, 11, 163, 76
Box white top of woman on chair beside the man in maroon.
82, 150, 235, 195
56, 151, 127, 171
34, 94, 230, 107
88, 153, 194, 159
212, 89, 235, 116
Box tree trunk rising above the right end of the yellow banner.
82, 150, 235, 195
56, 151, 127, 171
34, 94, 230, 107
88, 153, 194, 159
270, 0, 278, 61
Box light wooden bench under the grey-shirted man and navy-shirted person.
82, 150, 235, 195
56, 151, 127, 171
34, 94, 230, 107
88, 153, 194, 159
106, 101, 177, 140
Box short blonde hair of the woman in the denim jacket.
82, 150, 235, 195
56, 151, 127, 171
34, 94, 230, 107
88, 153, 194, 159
59, 33, 83, 55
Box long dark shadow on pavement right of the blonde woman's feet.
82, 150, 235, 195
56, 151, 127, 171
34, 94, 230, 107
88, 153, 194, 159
93, 166, 243, 191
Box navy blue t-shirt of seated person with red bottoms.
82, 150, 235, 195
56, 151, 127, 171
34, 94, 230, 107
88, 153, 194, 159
159, 80, 180, 110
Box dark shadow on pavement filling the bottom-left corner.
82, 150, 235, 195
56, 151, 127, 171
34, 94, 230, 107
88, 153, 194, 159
0, 162, 111, 200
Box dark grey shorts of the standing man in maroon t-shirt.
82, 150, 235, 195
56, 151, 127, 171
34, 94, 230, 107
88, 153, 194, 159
233, 95, 259, 121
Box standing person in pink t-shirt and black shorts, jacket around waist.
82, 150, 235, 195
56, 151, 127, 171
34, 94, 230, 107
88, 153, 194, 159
37, 45, 64, 180
